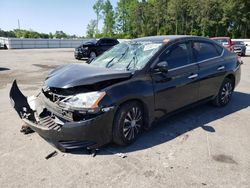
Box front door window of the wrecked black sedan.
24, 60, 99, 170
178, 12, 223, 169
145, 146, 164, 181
160, 43, 191, 69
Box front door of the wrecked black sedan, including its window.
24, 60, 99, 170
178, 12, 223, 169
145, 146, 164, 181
152, 41, 199, 118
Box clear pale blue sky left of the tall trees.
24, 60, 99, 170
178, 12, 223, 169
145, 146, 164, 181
0, 0, 117, 36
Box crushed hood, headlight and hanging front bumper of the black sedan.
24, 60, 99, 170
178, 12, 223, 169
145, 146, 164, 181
10, 62, 130, 151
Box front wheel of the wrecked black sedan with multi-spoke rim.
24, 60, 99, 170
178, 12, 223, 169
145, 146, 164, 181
113, 102, 144, 146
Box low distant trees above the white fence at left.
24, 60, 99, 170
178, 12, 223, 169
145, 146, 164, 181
0, 29, 78, 39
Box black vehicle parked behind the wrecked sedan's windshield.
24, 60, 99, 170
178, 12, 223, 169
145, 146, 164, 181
75, 38, 119, 59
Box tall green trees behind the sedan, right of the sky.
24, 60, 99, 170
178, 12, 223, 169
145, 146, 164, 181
87, 0, 250, 38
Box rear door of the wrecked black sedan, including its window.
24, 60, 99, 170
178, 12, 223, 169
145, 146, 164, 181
192, 40, 226, 100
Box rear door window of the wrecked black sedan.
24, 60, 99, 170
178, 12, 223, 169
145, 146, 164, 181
192, 41, 220, 62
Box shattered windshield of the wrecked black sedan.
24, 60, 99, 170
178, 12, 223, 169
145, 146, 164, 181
91, 42, 162, 70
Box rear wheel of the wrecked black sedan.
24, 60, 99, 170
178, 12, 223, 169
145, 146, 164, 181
213, 78, 234, 107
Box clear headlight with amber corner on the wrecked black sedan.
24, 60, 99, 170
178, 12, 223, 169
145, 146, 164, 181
59, 91, 106, 110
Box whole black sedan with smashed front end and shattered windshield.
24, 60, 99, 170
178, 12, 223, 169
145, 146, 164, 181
10, 36, 241, 151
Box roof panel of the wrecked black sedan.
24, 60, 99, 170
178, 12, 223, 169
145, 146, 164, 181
132, 35, 207, 42
